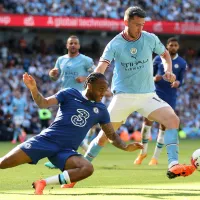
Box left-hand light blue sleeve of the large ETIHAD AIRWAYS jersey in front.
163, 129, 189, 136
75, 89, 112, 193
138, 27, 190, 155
99, 42, 115, 64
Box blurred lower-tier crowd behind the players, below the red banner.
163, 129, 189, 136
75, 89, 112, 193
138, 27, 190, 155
0, 38, 200, 140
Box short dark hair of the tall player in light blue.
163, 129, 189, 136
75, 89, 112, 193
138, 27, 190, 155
124, 6, 146, 20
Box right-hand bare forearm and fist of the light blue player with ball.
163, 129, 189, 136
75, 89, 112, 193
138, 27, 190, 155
161, 50, 176, 83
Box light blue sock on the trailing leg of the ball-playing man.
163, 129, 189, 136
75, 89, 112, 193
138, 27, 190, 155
84, 138, 103, 162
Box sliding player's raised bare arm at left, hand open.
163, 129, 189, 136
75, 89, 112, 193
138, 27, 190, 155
23, 73, 58, 108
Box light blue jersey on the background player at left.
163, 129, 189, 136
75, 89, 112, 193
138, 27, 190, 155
55, 54, 94, 91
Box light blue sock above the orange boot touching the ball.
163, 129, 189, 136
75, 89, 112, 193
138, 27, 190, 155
164, 129, 179, 165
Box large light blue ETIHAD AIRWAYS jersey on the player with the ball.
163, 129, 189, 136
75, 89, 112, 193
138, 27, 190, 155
100, 31, 165, 94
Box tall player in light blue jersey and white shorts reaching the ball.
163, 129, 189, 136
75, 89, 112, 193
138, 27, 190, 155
79, 6, 195, 184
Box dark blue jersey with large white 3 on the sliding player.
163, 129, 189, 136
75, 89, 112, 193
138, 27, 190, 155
40, 89, 110, 150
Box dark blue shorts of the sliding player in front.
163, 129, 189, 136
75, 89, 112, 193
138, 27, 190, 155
19, 135, 82, 171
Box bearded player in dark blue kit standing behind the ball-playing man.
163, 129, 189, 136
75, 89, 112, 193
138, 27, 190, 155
134, 37, 187, 165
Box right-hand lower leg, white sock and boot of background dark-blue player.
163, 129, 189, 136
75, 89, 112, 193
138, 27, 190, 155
149, 129, 164, 165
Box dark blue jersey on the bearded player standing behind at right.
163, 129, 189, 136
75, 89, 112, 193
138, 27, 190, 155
153, 54, 187, 100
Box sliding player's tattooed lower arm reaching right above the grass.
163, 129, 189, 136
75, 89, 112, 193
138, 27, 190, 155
101, 123, 143, 151
